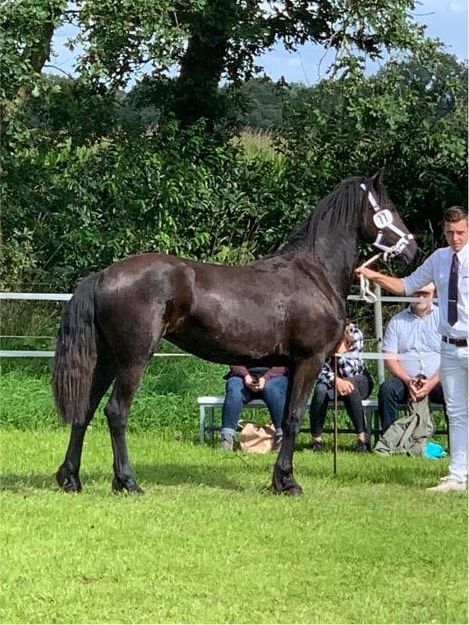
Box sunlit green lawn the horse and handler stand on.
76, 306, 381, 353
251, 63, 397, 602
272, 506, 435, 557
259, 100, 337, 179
0, 427, 467, 623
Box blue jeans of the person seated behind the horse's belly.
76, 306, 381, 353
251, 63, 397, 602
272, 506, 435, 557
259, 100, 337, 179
221, 375, 288, 436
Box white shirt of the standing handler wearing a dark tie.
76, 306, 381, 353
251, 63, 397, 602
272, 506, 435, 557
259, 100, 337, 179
403, 242, 469, 339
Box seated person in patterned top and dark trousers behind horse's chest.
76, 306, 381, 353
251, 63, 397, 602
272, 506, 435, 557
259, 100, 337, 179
309, 322, 373, 453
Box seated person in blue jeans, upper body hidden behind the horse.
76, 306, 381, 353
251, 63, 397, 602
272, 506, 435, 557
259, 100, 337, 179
220, 367, 288, 451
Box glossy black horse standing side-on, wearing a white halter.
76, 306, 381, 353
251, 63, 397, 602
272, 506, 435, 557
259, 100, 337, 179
54, 174, 417, 494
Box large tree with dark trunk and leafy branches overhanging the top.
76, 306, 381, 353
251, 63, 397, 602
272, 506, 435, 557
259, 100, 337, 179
3, 0, 432, 129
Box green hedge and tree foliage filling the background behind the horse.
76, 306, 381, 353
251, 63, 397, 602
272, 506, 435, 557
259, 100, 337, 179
0, 0, 467, 292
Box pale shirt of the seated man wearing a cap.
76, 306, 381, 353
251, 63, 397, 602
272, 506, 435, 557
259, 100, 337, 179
383, 306, 441, 378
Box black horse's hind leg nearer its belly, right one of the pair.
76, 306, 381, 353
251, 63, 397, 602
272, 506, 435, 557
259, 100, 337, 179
104, 362, 147, 494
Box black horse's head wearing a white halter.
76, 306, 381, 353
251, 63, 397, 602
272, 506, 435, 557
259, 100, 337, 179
360, 170, 417, 262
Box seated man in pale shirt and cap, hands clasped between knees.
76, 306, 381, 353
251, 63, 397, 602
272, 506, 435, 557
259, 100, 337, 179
378, 282, 443, 432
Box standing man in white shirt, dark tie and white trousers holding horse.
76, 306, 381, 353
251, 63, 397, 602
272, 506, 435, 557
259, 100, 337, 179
356, 206, 469, 493
